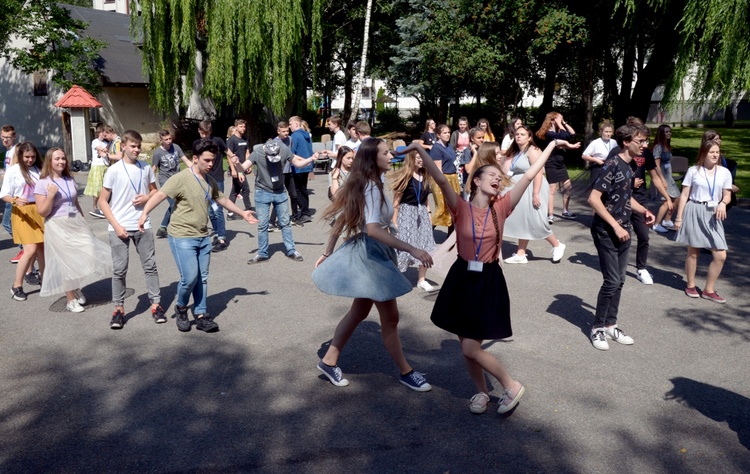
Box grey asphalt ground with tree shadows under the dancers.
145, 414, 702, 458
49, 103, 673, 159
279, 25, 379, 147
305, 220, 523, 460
0, 175, 750, 473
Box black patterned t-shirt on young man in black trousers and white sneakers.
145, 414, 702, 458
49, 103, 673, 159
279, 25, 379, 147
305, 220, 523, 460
594, 155, 633, 228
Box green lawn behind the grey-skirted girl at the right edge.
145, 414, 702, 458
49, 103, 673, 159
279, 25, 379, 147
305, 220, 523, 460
672, 127, 750, 198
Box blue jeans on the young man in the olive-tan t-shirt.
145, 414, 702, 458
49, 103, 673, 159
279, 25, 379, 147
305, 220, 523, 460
169, 235, 211, 316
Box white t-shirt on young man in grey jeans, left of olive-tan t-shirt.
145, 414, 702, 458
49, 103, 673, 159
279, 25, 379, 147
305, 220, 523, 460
103, 158, 156, 232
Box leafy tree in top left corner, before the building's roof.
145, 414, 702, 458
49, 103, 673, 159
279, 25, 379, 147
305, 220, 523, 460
2, 0, 106, 94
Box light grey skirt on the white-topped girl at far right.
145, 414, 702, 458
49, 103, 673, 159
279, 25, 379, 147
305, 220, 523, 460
675, 201, 728, 250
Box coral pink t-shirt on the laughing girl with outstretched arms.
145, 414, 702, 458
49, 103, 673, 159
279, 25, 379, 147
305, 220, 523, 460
449, 193, 513, 263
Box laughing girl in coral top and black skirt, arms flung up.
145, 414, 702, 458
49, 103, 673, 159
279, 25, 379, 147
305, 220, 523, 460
405, 140, 569, 414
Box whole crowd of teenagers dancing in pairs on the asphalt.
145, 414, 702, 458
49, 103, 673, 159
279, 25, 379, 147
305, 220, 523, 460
0, 112, 738, 414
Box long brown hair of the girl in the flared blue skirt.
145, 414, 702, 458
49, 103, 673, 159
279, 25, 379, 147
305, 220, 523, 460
323, 138, 385, 237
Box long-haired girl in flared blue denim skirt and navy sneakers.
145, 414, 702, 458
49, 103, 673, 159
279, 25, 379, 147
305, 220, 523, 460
312, 138, 432, 392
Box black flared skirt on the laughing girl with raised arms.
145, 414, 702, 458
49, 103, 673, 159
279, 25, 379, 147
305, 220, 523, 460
430, 257, 513, 340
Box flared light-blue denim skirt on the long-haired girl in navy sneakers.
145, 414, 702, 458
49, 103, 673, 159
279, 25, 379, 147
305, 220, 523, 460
312, 234, 412, 301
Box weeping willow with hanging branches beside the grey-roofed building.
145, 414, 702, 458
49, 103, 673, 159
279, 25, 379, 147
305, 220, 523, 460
131, 0, 323, 114
